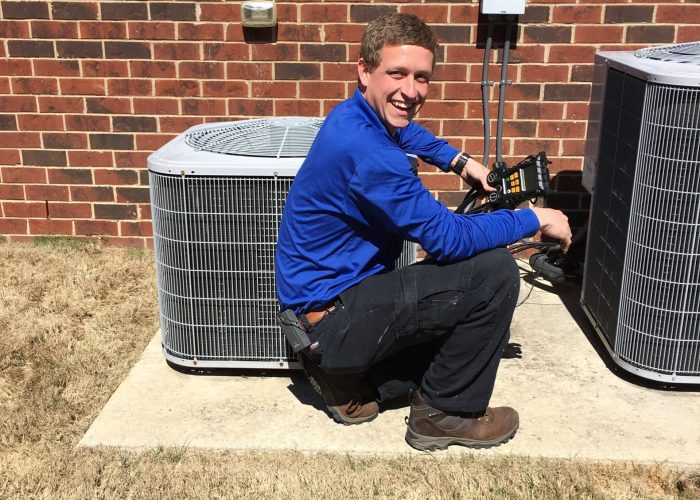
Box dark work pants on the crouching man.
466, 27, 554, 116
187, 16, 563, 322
308, 249, 520, 412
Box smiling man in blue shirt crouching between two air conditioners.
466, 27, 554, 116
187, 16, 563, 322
276, 14, 571, 449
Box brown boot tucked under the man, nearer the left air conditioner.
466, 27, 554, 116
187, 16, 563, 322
300, 353, 379, 425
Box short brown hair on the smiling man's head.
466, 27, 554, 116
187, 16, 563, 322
360, 12, 438, 69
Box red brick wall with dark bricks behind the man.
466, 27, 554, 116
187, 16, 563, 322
0, 0, 700, 247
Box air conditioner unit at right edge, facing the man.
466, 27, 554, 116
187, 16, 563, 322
581, 43, 700, 384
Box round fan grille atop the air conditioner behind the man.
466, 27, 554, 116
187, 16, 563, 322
185, 118, 323, 158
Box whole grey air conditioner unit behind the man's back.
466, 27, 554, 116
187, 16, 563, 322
148, 118, 416, 369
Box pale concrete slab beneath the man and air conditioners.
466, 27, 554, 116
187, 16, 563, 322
80, 276, 700, 465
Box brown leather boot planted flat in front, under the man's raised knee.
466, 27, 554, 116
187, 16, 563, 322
406, 390, 519, 451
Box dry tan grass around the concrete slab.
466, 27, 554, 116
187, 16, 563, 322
0, 239, 700, 499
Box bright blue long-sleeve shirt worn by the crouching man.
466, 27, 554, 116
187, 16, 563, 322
275, 90, 539, 314
